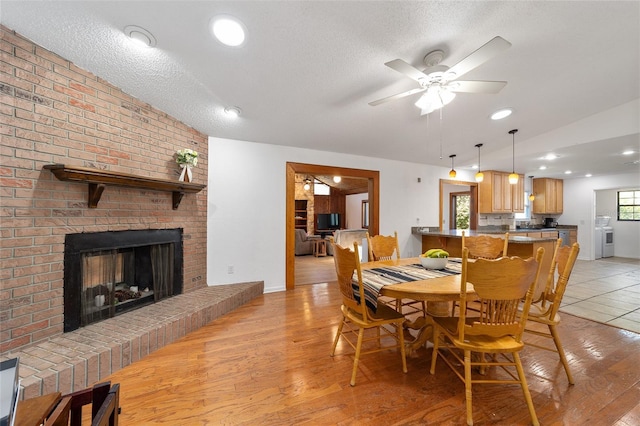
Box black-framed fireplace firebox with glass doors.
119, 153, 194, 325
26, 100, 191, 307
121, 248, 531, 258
64, 229, 183, 332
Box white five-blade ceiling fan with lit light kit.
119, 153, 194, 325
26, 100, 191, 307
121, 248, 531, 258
369, 36, 511, 115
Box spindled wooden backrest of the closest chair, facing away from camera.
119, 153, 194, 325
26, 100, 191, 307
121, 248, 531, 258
458, 247, 544, 341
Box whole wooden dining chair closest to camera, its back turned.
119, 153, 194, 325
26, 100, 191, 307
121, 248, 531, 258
431, 247, 544, 425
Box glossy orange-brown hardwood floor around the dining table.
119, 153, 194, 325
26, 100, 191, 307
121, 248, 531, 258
101, 274, 640, 426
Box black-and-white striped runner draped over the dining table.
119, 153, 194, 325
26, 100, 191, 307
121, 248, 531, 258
353, 260, 462, 312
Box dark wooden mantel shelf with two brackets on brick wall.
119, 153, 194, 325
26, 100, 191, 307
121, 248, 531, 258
43, 164, 206, 210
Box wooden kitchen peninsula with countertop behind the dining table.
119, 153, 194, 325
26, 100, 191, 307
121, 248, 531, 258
411, 227, 558, 298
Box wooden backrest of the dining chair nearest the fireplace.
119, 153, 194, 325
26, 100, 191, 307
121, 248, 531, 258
333, 242, 367, 321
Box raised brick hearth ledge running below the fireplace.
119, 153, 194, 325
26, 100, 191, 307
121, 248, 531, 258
9, 281, 264, 398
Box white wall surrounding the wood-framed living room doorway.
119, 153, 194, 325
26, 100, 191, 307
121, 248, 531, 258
207, 137, 449, 292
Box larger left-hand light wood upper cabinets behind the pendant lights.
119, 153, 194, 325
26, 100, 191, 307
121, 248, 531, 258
478, 170, 524, 213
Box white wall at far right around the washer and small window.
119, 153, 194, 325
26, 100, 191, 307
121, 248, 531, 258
558, 173, 640, 260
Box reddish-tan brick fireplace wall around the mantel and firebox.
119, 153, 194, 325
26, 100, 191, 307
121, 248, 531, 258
0, 26, 208, 356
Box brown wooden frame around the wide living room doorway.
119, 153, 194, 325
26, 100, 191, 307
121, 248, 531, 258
285, 162, 380, 290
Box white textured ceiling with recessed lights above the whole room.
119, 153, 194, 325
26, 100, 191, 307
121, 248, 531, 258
0, 0, 640, 177
